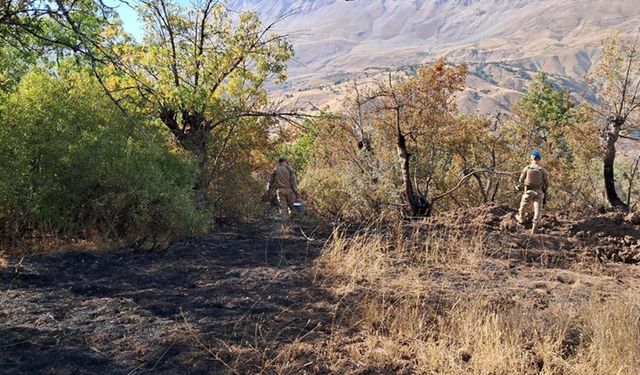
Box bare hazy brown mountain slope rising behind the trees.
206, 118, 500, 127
228, 0, 640, 113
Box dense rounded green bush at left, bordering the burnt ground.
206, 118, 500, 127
0, 71, 205, 247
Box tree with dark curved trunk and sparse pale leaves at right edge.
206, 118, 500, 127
589, 33, 640, 210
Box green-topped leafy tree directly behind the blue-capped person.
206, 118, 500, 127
509, 73, 600, 208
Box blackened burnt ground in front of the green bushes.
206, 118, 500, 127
0, 226, 332, 374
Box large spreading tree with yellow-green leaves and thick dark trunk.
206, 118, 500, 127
102, 0, 293, 204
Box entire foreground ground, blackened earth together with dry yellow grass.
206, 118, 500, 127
5, 210, 640, 375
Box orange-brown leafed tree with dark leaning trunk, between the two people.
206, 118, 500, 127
362, 59, 467, 216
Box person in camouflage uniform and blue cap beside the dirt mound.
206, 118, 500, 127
516, 150, 549, 233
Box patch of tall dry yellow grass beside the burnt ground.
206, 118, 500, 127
319, 227, 640, 375
